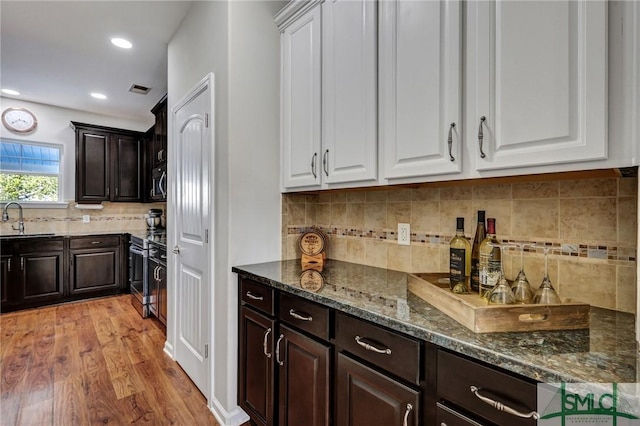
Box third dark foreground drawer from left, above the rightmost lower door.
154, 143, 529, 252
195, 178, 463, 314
336, 313, 420, 384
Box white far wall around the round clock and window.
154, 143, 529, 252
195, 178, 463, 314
0, 97, 154, 200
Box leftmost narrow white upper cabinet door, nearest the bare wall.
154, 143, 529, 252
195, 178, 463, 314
281, 7, 322, 188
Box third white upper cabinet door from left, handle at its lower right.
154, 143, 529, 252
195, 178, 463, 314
380, 0, 462, 179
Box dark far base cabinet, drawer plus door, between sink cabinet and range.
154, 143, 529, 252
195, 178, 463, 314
69, 235, 126, 297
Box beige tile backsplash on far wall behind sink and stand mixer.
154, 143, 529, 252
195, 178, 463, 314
0, 202, 166, 235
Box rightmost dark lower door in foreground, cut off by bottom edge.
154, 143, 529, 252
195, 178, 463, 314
336, 353, 420, 426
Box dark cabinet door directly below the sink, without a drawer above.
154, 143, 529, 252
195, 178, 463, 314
19, 250, 64, 306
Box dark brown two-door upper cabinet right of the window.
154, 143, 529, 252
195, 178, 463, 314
71, 121, 144, 203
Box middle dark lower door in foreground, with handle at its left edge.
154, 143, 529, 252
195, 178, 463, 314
276, 325, 331, 426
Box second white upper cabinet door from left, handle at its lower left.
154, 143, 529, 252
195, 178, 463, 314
322, 0, 377, 184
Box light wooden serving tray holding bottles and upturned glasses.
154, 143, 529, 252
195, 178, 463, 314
407, 273, 590, 333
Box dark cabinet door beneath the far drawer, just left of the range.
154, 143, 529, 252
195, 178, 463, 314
69, 247, 122, 295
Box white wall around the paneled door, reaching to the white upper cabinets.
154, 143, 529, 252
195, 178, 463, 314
167, 1, 282, 425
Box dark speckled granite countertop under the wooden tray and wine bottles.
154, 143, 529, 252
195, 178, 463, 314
232, 260, 640, 383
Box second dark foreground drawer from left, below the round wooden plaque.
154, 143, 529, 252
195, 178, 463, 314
279, 293, 329, 340
